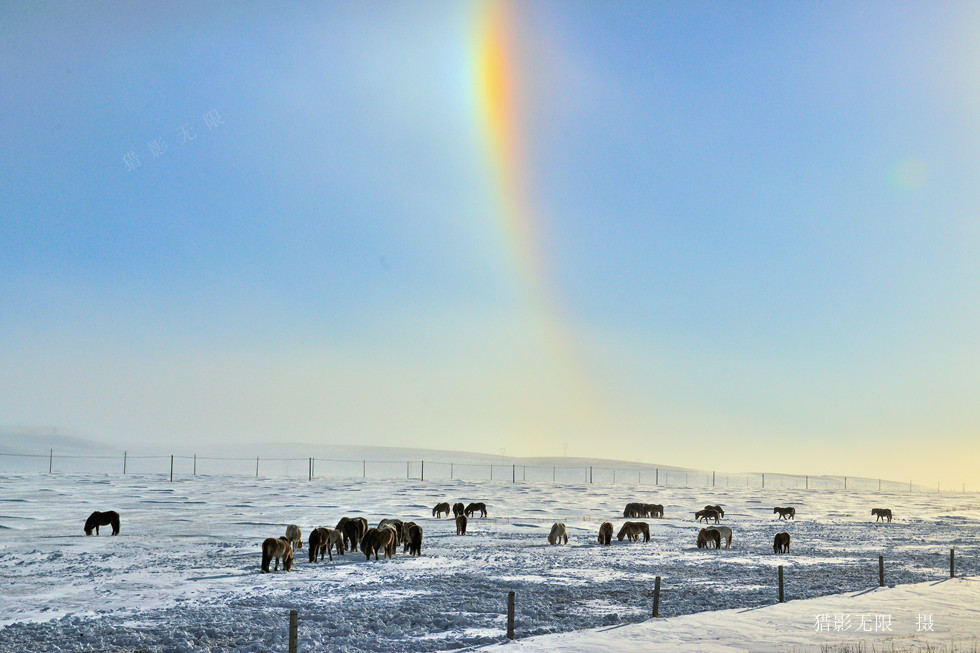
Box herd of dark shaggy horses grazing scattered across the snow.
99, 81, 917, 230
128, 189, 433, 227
84, 502, 892, 572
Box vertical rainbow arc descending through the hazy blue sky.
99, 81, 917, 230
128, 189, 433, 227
471, 0, 605, 444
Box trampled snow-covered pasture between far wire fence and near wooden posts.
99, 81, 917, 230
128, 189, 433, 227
0, 473, 980, 651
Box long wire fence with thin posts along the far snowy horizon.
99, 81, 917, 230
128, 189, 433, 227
0, 449, 966, 493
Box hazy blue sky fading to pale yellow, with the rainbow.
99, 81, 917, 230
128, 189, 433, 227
0, 2, 980, 489
